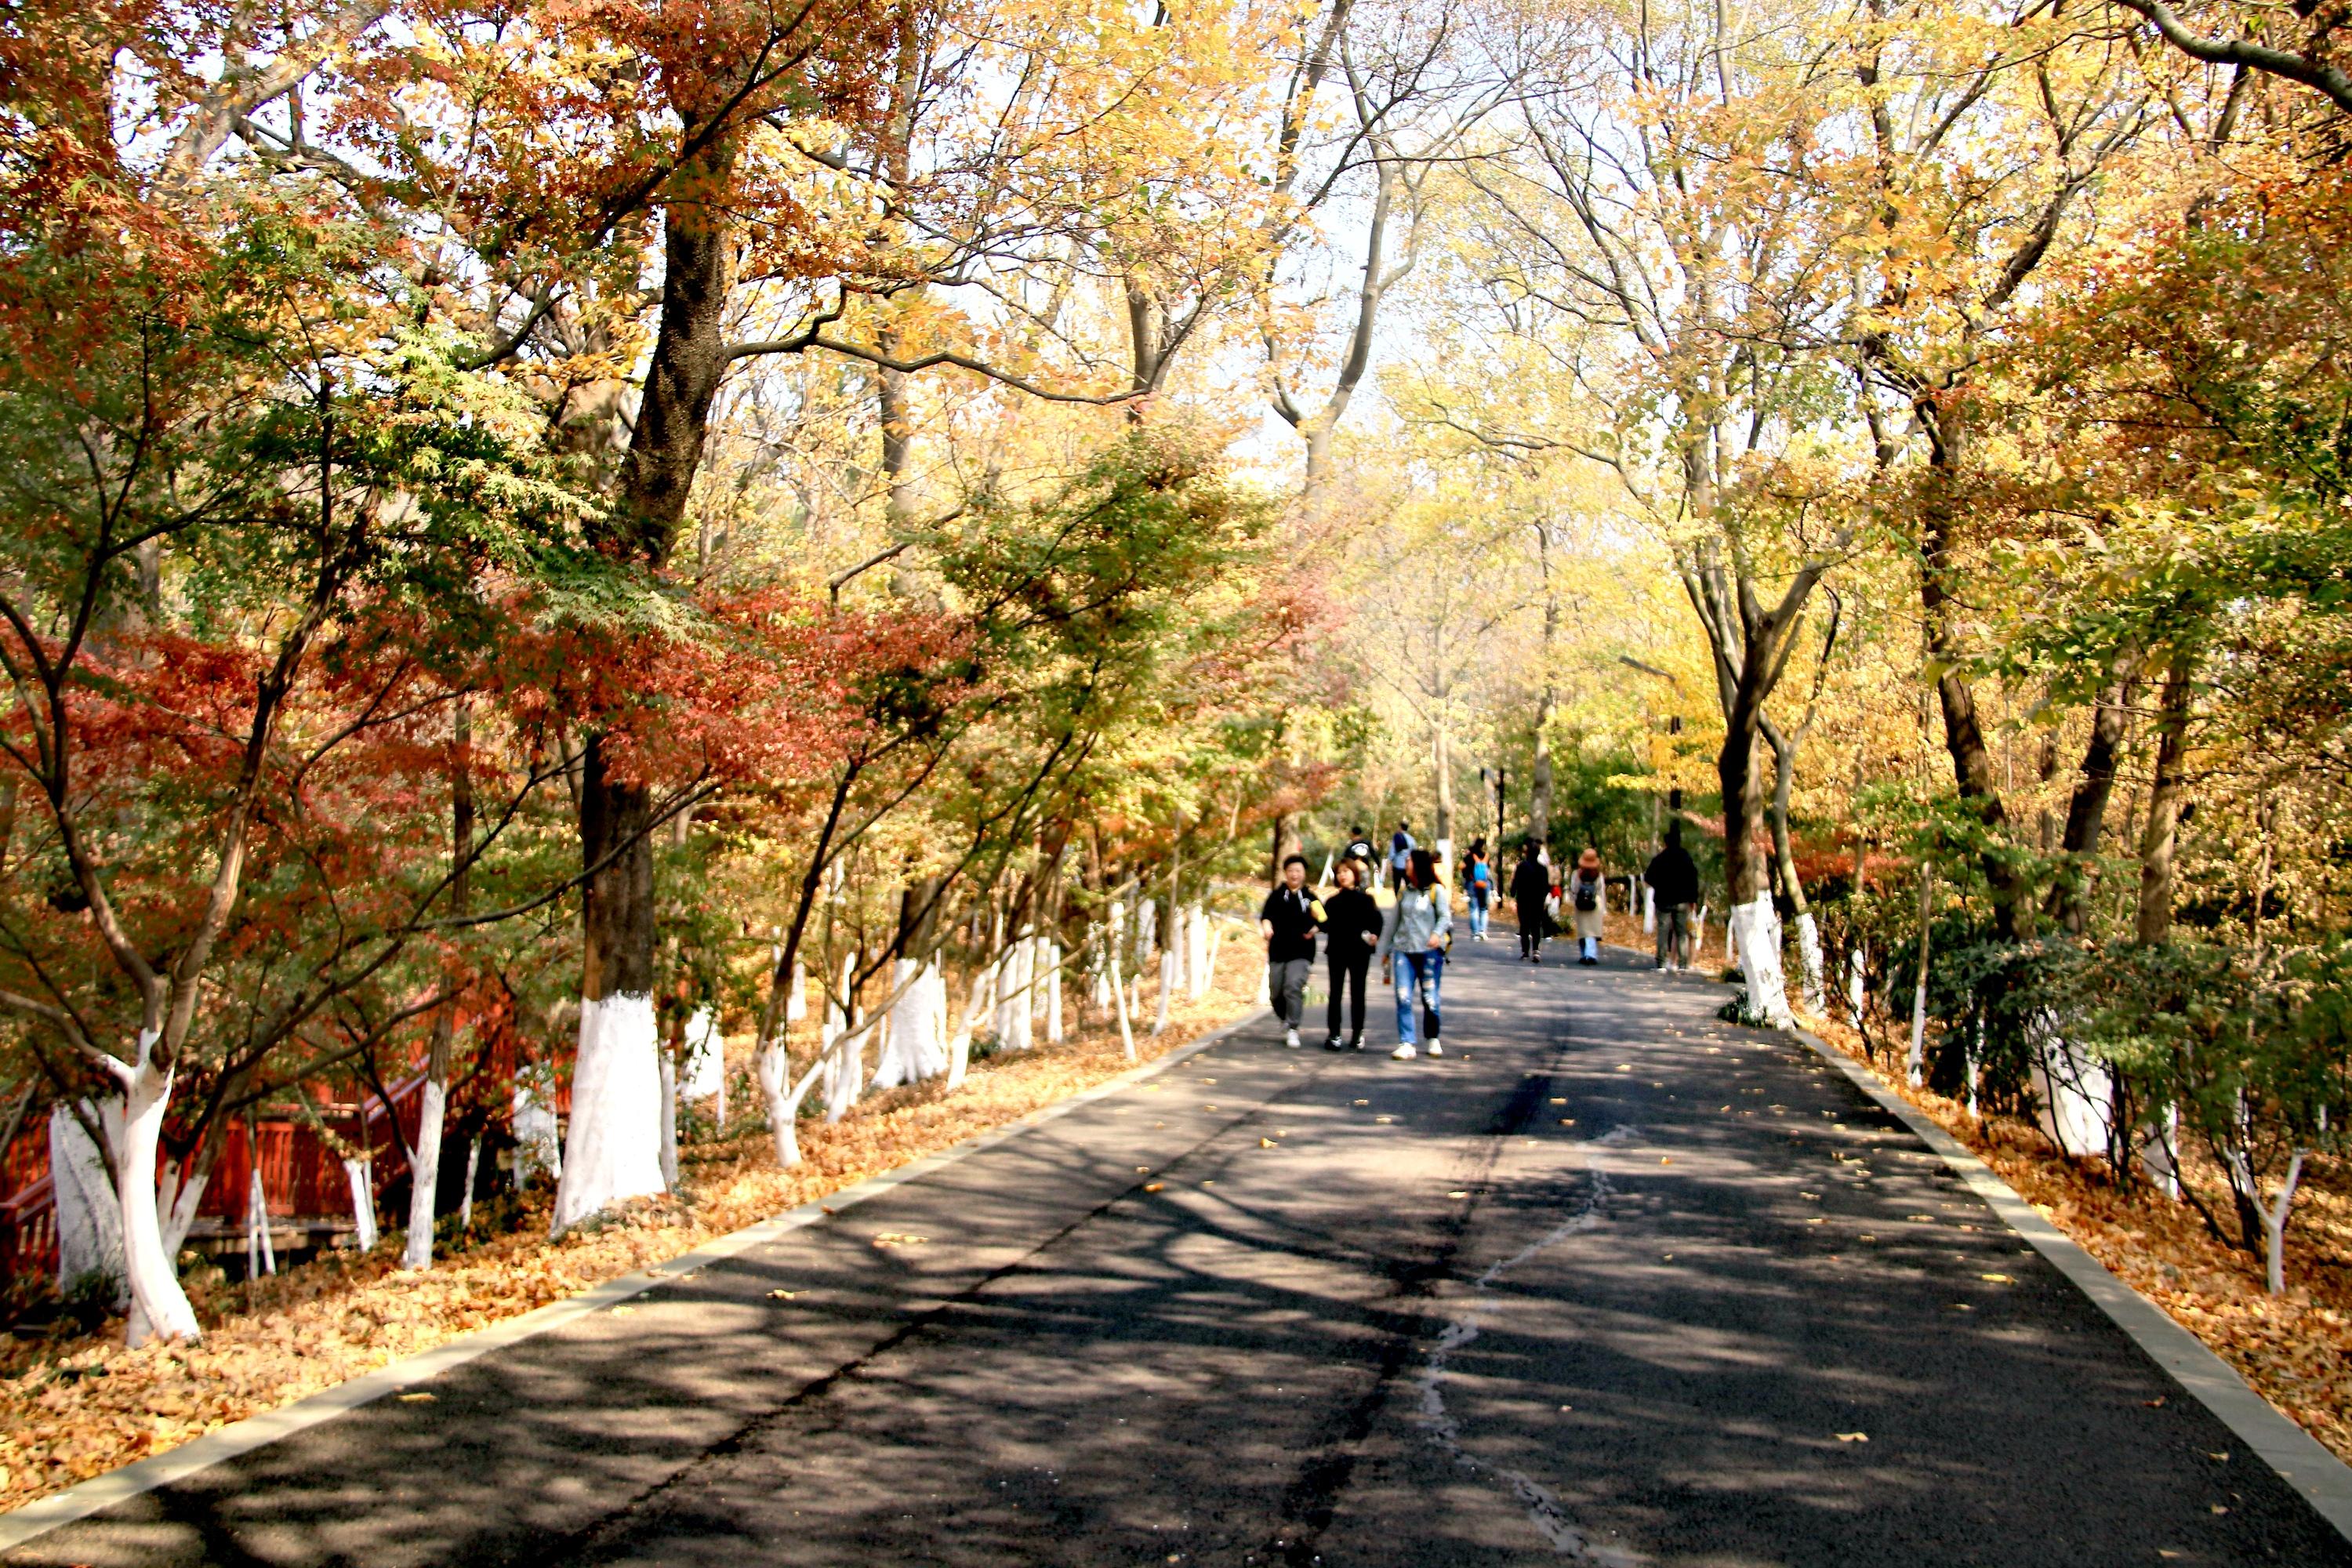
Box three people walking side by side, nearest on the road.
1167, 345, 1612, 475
1258, 846, 1454, 1060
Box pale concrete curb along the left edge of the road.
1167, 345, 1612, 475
0, 1006, 1268, 1552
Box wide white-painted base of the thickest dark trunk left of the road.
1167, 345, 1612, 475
550, 992, 668, 1234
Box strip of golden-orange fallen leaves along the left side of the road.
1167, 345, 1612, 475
0, 961, 1258, 1509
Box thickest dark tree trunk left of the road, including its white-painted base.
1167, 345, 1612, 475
553, 125, 734, 1232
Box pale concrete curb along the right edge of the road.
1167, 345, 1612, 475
1795, 1029, 2352, 1542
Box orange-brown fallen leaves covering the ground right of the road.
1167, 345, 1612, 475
1806, 1018, 2352, 1462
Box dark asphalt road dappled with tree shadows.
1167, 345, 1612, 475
14, 940, 2352, 1568
